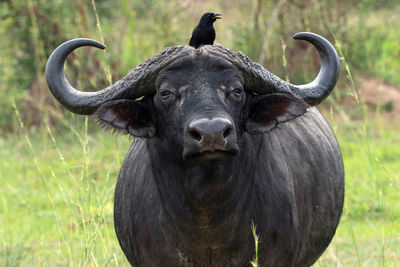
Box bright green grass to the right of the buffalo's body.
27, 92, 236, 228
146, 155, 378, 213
316, 121, 400, 266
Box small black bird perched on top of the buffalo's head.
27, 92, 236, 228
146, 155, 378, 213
189, 12, 221, 48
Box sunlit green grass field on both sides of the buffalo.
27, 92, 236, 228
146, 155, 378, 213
0, 111, 400, 266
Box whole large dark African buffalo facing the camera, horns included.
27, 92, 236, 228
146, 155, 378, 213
46, 33, 344, 267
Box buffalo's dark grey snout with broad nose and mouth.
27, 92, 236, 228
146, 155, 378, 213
183, 117, 238, 158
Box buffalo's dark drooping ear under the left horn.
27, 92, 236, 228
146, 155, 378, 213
96, 99, 155, 137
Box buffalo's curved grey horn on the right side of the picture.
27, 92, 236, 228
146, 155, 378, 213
209, 32, 340, 106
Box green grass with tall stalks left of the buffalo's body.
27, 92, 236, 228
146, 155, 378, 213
0, 121, 129, 266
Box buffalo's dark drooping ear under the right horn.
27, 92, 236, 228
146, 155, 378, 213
245, 94, 307, 134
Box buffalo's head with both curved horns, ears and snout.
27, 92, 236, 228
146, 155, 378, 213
46, 33, 339, 165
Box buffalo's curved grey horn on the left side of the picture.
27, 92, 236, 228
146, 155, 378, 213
46, 38, 188, 115
